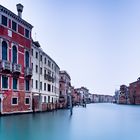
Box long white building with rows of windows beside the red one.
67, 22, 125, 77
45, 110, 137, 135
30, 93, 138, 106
31, 41, 60, 111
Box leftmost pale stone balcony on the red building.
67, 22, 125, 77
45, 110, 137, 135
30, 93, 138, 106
0, 60, 12, 72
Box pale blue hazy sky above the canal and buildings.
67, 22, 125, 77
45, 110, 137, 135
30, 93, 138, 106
0, 0, 140, 95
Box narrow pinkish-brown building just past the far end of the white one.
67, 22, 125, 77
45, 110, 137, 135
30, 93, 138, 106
59, 71, 71, 108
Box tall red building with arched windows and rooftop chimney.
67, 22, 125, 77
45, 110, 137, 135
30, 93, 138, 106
0, 4, 32, 114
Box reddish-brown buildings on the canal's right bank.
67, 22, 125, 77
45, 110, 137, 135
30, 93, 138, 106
114, 78, 140, 104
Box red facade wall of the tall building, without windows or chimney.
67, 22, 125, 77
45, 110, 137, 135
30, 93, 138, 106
0, 6, 32, 114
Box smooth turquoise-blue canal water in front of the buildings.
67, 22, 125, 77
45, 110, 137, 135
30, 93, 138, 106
0, 103, 140, 140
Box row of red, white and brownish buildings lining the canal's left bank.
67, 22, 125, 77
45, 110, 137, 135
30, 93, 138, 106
0, 4, 99, 114
